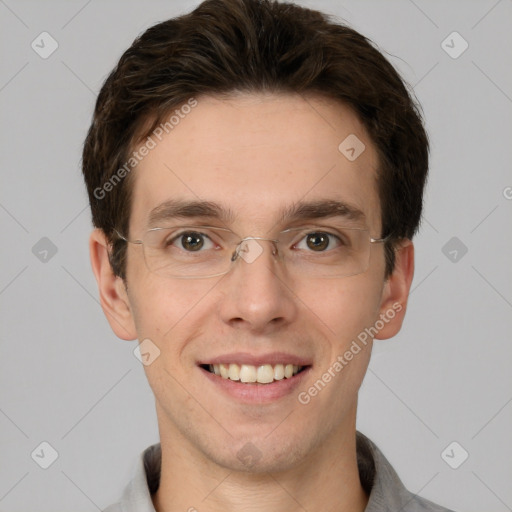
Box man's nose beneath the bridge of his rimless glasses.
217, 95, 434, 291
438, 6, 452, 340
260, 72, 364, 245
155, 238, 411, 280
220, 237, 297, 334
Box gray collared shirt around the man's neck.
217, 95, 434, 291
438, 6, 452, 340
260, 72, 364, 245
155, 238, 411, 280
104, 432, 451, 512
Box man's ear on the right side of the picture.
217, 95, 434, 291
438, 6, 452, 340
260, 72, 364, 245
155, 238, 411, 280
375, 240, 414, 340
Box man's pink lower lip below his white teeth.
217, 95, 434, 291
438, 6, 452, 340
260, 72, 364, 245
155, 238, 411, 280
199, 366, 311, 404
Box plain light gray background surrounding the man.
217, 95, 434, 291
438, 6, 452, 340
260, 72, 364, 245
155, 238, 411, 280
0, 0, 512, 512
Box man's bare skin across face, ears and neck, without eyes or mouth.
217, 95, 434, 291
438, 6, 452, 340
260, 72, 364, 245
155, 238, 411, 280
90, 94, 414, 512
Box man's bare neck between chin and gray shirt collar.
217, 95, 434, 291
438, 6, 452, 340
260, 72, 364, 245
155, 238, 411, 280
153, 416, 368, 512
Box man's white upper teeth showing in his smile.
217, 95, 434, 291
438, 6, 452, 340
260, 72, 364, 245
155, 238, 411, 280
209, 363, 302, 384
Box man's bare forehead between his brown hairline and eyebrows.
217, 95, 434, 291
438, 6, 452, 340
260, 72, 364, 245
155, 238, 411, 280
130, 94, 380, 230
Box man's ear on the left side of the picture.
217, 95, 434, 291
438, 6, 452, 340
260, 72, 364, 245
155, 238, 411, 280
89, 229, 137, 340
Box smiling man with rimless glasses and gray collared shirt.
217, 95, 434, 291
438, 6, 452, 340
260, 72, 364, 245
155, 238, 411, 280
83, 0, 454, 512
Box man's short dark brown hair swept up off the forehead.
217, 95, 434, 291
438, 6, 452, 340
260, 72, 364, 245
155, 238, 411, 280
82, 0, 429, 278
